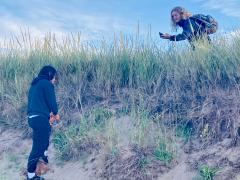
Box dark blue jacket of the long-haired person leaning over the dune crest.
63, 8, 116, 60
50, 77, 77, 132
170, 16, 210, 43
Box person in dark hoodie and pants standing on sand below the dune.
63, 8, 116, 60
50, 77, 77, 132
27, 66, 58, 180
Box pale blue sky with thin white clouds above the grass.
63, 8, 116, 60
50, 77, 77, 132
0, 0, 240, 39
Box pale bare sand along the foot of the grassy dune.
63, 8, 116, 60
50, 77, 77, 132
0, 125, 240, 180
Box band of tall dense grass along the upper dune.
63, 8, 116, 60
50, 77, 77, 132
0, 34, 240, 142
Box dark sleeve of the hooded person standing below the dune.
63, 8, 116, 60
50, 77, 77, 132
43, 82, 58, 115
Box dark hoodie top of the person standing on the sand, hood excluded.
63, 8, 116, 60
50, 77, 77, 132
28, 79, 58, 118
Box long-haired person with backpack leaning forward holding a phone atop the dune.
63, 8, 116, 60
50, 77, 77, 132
159, 7, 218, 48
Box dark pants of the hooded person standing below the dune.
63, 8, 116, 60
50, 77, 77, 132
27, 116, 51, 173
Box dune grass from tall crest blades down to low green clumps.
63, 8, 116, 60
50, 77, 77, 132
0, 31, 240, 178
